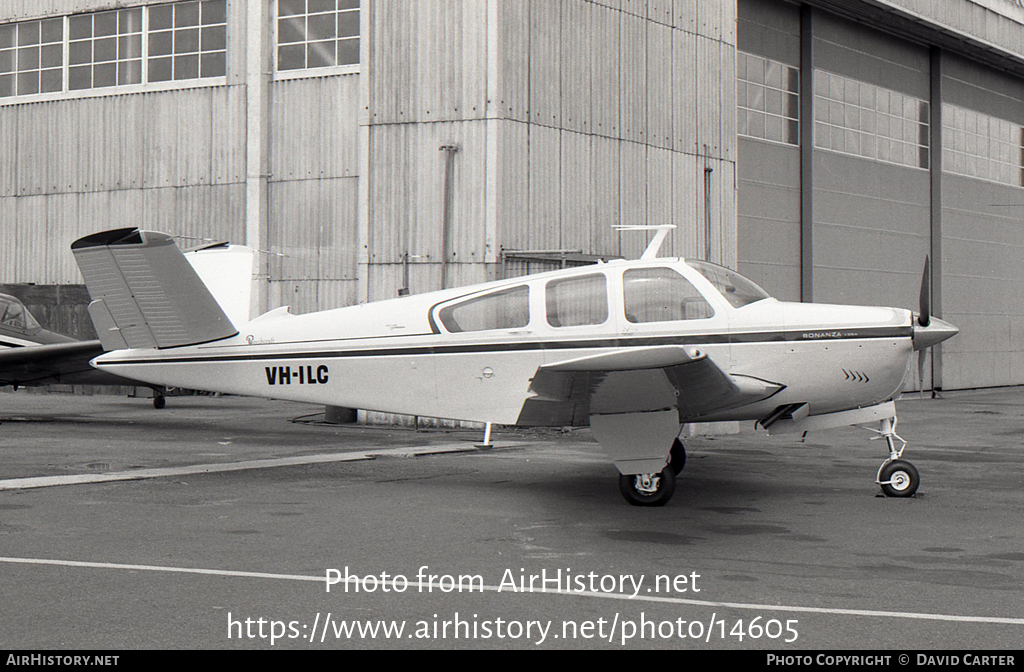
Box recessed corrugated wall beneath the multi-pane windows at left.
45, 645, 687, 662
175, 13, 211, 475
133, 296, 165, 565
0, 0, 358, 319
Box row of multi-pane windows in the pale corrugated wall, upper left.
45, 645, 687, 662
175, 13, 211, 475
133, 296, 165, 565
0, 0, 359, 98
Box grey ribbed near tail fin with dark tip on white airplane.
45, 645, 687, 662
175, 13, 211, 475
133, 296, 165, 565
71, 228, 239, 350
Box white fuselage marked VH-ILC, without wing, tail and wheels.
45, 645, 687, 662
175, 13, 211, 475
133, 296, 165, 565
88, 259, 913, 424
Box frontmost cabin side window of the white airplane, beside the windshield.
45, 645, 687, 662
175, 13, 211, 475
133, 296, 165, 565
623, 268, 715, 325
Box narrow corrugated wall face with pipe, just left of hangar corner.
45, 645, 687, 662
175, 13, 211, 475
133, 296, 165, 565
362, 0, 488, 300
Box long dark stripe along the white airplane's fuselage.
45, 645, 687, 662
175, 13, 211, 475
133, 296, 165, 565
97, 327, 912, 365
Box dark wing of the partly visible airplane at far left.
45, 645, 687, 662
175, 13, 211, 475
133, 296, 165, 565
0, 341, 137, 387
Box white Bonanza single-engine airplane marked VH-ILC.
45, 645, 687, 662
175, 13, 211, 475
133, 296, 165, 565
72, 227, 957, 505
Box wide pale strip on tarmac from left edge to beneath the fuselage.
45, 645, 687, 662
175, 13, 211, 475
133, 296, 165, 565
0, 444, 505, 491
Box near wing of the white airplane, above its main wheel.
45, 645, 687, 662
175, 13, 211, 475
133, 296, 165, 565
516, 345, 783, 426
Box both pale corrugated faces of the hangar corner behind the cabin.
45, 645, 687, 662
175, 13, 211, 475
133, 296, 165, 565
367, 0, 736, 299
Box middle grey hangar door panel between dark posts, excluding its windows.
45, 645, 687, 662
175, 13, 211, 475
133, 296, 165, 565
814, 14, 931, 308
